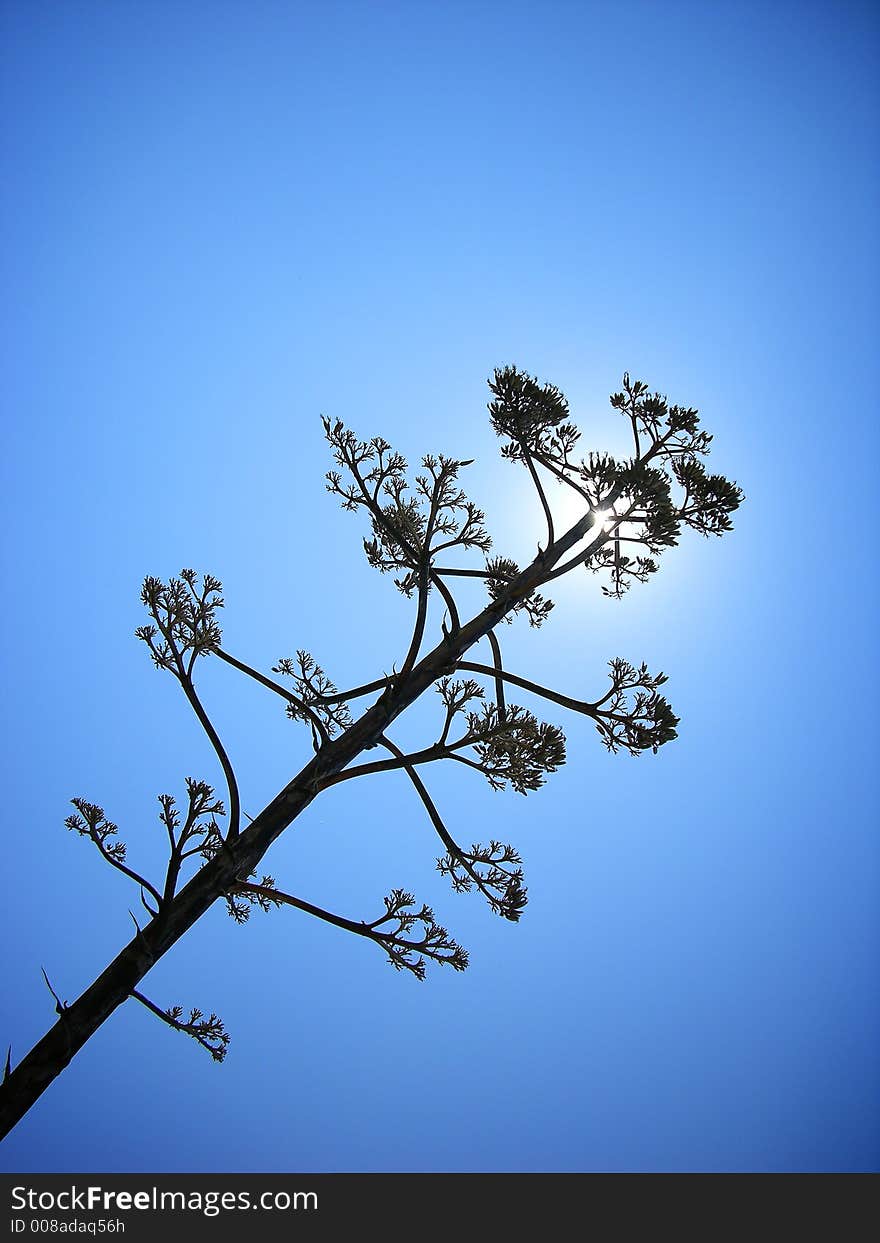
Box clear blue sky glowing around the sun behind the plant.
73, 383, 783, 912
0, 0, 880, 1171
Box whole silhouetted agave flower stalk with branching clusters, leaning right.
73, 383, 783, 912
0, 367, 742, 1134
